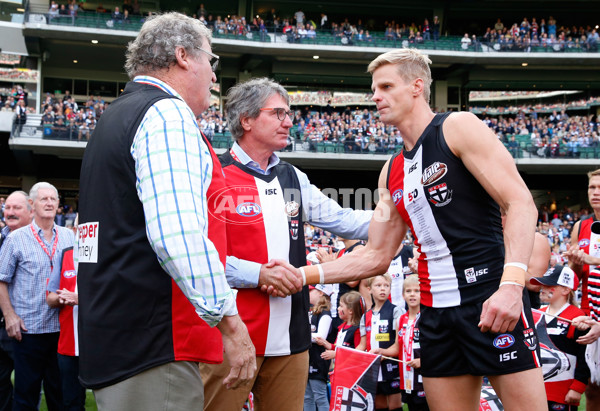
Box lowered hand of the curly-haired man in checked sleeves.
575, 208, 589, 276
217, 315, 256, 389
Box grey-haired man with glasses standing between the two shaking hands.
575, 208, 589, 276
200, 78, 372, 411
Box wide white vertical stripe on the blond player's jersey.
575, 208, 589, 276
402, 150, 460, 307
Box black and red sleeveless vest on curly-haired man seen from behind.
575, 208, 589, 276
78, 82, 227, 389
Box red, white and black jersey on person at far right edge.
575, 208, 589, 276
577, 217, 600, 320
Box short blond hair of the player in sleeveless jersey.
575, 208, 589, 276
367, 48, 433, 103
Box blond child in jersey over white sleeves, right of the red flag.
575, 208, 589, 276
357, 274, 402, 411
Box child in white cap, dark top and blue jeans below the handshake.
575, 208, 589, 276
304, 284, 333, 411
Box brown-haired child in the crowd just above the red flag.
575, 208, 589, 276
315, 291, 364, 360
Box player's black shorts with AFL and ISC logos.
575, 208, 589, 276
419, 293, 541, 377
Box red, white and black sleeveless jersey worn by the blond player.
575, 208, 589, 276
387, 113, 504, 307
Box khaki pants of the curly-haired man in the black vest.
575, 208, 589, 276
94, 361, 204, 411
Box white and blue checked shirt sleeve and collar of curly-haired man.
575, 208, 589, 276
130, 76, 237, 326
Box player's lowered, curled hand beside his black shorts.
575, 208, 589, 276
479, 284, 523, 333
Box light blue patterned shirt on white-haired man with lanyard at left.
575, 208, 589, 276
0, 221, 74, 334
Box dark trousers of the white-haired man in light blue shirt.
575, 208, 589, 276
13, 333, 62, 411
